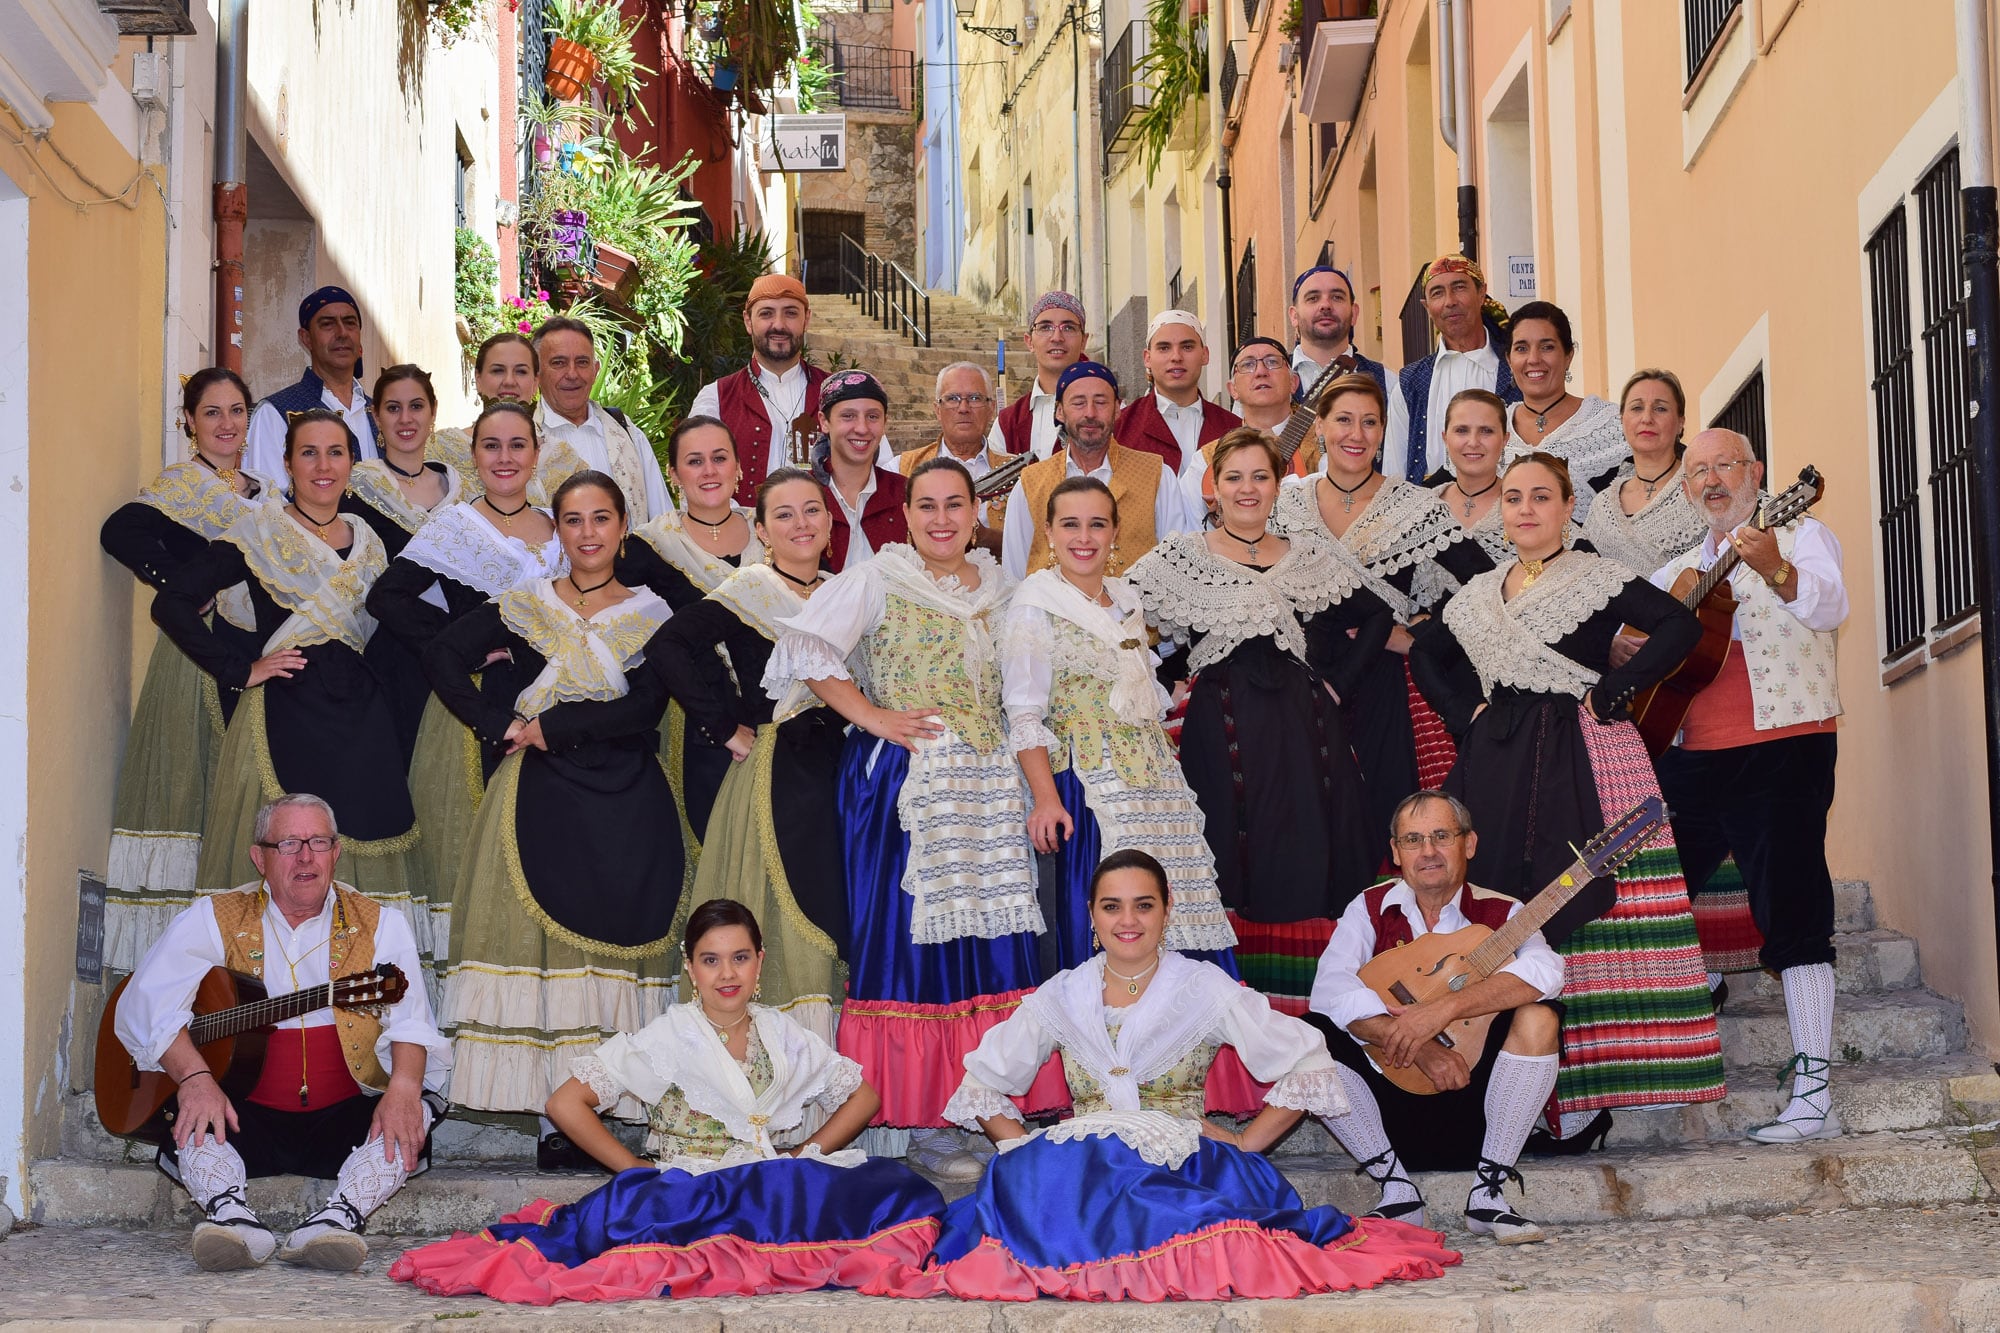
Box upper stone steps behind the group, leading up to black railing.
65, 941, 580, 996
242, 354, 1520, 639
806, 292, 1032, 450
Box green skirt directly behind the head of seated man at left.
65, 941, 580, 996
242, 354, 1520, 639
196, 685, 430, 953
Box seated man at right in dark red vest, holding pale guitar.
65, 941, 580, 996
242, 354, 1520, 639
1306, 791, 1562, 1245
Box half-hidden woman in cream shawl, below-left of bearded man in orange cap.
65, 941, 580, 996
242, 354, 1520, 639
618, 416, 764, 852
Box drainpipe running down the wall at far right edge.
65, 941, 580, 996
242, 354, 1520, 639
1956, 0, 2000, 1048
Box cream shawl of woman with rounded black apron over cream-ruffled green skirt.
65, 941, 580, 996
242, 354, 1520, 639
500, 578, 670, 717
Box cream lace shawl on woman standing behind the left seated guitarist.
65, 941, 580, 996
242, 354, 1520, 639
222, 504, 388, 652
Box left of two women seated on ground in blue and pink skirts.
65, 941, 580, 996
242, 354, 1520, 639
390, 899, 944, 1305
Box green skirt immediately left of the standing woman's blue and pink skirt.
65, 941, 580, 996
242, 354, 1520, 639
674, 723, 848, 1045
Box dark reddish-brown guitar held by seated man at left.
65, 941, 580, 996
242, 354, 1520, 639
96, 963, 410, 1145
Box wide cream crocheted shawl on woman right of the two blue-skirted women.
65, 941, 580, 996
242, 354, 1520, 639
1126, 528, 1364, 671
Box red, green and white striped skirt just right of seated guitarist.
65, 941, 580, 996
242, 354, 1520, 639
1554, 707, 1724, 1113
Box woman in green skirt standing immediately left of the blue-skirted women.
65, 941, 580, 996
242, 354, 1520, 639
646, 468, 848, 1041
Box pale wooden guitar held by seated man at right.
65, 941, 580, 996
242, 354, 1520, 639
1358, 797, 1666, 1095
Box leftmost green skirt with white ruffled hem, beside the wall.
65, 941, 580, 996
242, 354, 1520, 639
104, 634, 222, 973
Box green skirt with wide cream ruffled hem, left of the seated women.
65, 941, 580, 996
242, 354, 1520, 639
438, 755, 680, 1121
